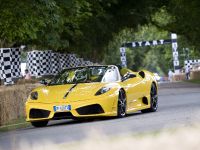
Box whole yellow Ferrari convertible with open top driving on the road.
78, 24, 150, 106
26, 65, 158, 127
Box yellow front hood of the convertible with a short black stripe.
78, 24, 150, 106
30, 83, 111, 103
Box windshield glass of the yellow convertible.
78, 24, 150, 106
49, 66, 108, 85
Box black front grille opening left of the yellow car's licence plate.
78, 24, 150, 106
29, 109, 50, 119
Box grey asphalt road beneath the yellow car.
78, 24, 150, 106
0, 83, 200, 150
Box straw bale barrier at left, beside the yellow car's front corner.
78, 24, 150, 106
0, 84, 38, 125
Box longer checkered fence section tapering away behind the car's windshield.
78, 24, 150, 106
27, 50, 93, 77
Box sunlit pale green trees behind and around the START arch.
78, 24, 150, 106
104, 24, 173, 74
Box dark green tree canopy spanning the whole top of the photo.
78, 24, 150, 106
0, 0, 200, 62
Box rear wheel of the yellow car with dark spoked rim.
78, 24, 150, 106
141, 83, 158, 113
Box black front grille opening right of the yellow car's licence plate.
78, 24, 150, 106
76, 104, 104, 115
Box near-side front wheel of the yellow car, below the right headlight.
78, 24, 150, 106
117, 90, 126, 118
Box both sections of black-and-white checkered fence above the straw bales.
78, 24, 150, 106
0, 48, 93, 85
